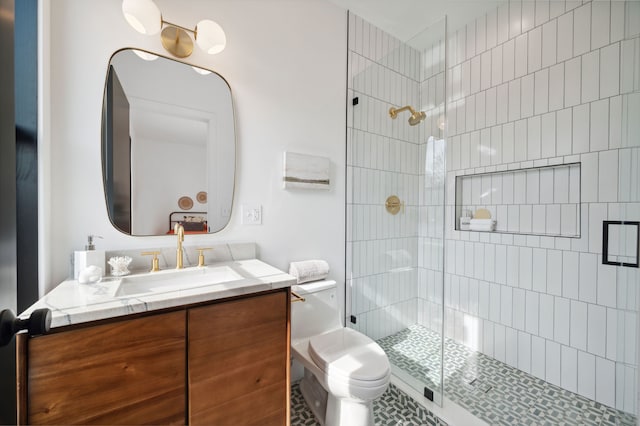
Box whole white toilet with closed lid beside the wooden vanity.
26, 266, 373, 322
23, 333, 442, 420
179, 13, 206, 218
291, 280, 391, 426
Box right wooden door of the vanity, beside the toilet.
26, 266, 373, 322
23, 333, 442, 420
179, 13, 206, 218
188, 291, 289, 425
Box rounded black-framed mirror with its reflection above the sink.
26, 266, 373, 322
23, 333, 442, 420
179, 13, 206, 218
102, 49, 235, 235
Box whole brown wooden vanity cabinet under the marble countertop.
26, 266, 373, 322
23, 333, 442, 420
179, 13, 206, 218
17, 289, 290, 425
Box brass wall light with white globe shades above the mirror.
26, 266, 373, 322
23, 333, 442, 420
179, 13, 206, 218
122, 0, 227, 58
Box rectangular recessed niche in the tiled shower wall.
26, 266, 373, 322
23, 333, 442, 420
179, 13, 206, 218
455, 163, 581, 238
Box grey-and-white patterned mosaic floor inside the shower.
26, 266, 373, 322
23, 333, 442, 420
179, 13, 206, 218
378, 325, 636, 426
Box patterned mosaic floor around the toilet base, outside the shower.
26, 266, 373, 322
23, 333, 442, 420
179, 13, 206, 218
291, 383, 447, 426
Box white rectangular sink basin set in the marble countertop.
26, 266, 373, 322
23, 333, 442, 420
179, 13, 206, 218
115, 266, 244, 297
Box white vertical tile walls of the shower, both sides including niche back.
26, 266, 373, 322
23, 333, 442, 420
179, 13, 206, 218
347, 0, 640, 413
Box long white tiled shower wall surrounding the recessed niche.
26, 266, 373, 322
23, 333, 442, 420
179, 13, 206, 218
440, 0, 640, 413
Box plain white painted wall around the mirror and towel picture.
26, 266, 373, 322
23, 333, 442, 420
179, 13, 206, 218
40, 0, 347, 306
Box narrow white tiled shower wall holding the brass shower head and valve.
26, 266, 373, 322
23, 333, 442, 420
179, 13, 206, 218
346, 14, 424, 339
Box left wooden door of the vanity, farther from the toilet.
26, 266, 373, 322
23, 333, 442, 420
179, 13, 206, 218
27, 311, 186, 424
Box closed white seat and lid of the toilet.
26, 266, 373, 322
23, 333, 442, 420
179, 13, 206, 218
309, 327, 390, 387
